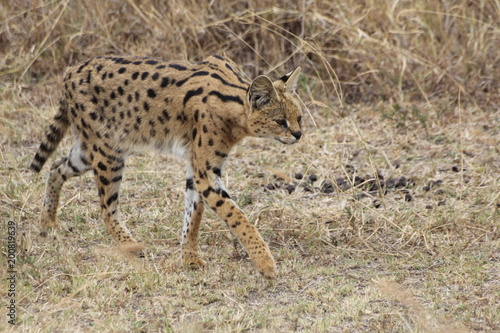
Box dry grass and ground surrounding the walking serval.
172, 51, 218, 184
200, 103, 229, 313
0, 0, 500, 332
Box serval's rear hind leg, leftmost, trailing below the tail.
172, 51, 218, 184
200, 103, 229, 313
40, 140, 90, 235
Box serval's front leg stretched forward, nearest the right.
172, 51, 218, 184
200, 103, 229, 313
194, 160, 276, 279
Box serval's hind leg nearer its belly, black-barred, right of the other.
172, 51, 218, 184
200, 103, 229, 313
92, 146, 144, 252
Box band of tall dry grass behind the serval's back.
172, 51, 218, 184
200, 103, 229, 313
0, 0, 500, 109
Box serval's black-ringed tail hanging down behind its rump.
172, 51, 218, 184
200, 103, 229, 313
30, 99, 69, 172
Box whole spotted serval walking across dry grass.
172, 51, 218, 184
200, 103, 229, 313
31, 56, 302, 278
